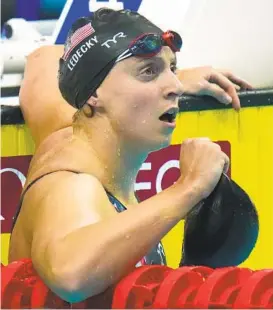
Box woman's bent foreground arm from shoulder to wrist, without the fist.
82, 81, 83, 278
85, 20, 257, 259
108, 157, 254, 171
29, 172, 199, 302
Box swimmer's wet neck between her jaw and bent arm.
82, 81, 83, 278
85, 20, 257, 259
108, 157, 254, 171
74, 124, 149, 204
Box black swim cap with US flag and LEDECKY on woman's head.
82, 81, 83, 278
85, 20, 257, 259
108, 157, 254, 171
59, 8, 163, 109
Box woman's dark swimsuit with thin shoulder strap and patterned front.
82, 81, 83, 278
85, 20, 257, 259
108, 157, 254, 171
12, 170, 167, 266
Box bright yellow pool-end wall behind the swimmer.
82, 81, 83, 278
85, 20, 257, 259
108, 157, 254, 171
1, 106, 273, 270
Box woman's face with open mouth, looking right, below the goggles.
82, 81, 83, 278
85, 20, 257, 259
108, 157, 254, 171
94, 47, 182, 150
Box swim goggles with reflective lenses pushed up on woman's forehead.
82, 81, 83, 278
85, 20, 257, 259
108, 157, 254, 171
116, 31, 182, 62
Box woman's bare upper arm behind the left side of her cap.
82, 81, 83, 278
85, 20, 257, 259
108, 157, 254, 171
19, 45, 76, 147
